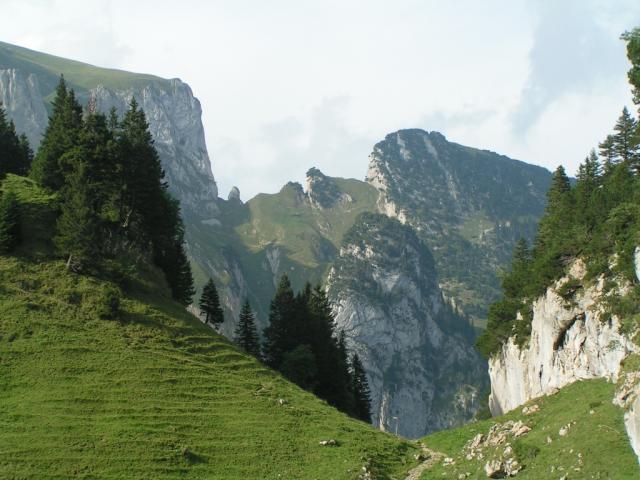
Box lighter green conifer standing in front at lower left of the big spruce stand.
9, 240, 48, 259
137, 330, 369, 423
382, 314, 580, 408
54, 161, 100, 272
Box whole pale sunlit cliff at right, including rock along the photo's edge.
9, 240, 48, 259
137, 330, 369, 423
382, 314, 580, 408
489, 256, 640, 460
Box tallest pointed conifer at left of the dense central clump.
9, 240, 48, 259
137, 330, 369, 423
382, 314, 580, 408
263, 275, 297, 370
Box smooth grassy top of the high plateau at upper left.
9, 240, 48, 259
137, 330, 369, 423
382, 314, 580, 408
0, 42, 168, 101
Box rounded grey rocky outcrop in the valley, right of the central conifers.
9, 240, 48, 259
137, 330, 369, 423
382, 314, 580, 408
328, 214, 486, 438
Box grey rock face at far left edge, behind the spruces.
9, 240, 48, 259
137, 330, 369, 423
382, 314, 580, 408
0, 69, 49, 149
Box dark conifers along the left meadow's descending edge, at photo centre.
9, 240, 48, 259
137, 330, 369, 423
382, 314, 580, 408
200, 275, 371, 422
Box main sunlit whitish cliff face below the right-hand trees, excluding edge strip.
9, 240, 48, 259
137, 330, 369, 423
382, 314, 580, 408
489, 261, 637, 415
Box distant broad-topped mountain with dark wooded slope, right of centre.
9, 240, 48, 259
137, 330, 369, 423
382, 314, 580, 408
366, 129, 551, 324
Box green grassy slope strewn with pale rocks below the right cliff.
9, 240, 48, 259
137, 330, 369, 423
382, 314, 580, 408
421, 380, 640, 479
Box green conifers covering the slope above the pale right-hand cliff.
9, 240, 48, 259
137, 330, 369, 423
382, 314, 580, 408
477, 29, 640, 357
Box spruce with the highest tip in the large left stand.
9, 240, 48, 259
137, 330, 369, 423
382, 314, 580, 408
31, 76, 82, 190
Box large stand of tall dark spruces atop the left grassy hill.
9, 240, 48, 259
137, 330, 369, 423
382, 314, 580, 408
0, 77, 194, 305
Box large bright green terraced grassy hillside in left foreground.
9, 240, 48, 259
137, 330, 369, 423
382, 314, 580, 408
0, 177, 415, 479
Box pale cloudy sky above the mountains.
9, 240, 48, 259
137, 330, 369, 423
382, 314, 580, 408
0, 0, 640, 200
